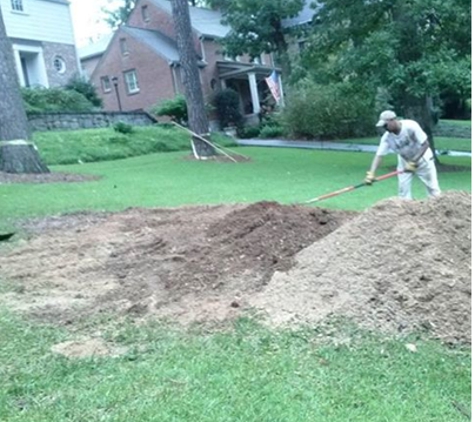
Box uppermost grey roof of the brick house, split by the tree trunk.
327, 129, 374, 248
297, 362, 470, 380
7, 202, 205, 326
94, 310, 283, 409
151, 0, 230, 38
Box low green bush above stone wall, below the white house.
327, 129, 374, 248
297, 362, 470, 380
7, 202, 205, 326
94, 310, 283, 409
21, 88, 94, 113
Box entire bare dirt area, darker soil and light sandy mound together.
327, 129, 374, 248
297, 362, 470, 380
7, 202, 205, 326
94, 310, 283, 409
0, 192, 471, 342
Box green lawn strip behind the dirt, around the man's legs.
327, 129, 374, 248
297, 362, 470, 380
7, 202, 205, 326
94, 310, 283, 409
0, 147, 471, 222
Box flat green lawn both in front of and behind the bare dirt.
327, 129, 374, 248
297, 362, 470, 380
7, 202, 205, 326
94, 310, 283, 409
0, 137, 471, 422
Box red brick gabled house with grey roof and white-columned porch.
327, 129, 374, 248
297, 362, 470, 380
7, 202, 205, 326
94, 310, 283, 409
89, 0, 282, 125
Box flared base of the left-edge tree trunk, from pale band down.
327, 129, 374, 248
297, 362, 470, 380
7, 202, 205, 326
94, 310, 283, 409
0, 140, 50, 174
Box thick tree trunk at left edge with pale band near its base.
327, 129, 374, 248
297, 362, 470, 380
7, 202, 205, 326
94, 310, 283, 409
0, 5, 49, 173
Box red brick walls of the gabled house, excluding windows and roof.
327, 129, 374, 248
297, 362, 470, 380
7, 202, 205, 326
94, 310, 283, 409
92, 0, 272, 111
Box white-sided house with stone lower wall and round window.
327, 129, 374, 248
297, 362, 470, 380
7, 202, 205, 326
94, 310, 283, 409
0, 0, 79, 88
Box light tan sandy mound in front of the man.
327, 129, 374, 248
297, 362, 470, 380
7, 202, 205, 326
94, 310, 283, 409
249, 192, 471, 342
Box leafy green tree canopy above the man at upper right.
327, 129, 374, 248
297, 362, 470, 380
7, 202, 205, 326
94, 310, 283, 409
300, 0, 471, 113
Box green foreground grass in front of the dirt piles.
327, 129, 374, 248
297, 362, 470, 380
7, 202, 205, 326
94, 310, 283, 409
0, 313, 470, 422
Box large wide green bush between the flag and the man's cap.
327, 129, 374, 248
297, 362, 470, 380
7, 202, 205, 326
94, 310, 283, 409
282, 80, 376, 139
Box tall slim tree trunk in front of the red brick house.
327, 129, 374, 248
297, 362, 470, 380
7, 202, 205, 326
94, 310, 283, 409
172, 0, 216, 157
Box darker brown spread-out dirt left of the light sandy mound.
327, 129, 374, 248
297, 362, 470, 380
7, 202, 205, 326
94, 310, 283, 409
0, 202, 355, 323
